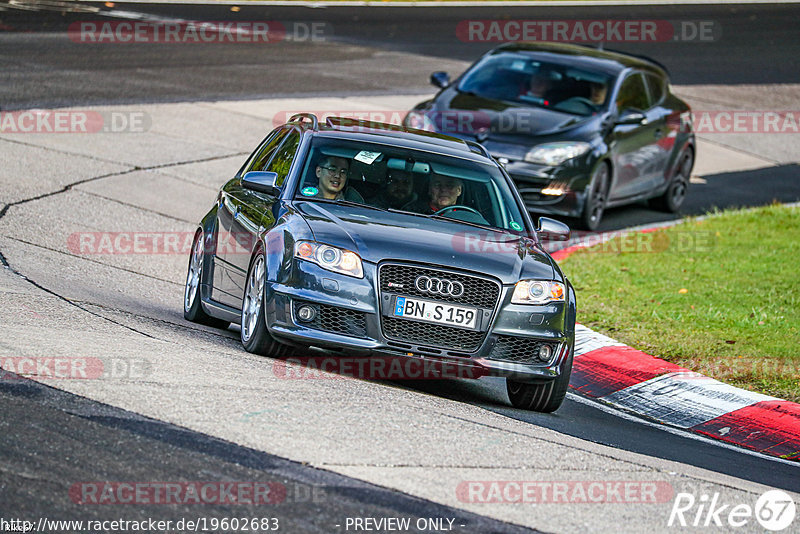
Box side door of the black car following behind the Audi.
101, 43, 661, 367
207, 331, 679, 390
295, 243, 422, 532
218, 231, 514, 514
609, 71, 664, 200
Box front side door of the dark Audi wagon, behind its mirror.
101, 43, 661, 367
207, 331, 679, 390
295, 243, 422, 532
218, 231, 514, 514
212, 129, 290, 308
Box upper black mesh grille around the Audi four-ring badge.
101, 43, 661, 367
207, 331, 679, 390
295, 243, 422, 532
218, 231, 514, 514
378, 264, 500, 310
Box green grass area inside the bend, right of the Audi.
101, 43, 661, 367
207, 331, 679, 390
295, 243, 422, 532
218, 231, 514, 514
562, 205, 800, 402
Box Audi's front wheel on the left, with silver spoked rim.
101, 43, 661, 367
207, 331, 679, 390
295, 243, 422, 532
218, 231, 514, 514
240, 247, 293, 358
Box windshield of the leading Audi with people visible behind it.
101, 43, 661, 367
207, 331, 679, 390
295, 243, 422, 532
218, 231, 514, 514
295, 137, 526, 233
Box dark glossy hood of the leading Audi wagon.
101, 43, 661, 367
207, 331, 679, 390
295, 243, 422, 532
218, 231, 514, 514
296, 201, 555, 284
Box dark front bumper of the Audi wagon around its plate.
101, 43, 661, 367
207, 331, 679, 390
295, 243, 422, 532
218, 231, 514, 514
265, 259, 574, 381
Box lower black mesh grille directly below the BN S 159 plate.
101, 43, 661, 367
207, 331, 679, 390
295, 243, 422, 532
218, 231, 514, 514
383, 317, 486, 352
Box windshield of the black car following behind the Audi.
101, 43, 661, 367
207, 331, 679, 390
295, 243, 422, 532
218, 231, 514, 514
458, 53, 611, 116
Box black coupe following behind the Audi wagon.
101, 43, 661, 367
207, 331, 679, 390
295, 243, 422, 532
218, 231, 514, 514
404, 43, 696, 230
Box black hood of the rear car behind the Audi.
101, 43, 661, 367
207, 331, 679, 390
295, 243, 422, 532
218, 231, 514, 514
428, 88, 597, 145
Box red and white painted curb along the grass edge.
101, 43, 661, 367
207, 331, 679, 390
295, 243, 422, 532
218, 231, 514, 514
552, 218, 800, 461
